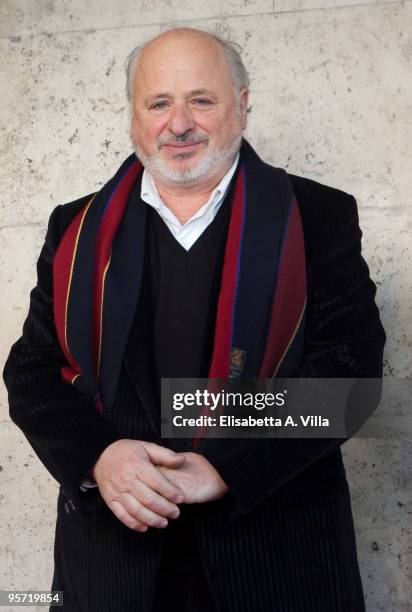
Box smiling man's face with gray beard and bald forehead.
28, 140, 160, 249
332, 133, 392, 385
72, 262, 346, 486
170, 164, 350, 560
131, 35, 248, 183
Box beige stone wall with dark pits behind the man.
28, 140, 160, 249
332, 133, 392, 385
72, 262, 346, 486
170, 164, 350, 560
0, 0, 412, 612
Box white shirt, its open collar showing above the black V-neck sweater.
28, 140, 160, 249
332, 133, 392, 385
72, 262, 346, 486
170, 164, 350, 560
80, 153, 239, 491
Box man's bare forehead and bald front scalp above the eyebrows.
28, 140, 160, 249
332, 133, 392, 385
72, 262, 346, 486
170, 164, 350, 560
134, 37, 233, 95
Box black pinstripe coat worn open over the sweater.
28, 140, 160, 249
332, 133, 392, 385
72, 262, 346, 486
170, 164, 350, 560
4, 141, 385, 612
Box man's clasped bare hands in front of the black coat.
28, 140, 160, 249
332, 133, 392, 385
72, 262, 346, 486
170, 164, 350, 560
92, 440, 228, 532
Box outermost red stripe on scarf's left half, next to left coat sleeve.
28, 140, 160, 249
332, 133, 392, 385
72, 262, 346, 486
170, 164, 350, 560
53, 196, 95, 383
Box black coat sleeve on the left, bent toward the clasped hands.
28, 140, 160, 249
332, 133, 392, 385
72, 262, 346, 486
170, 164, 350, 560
3, 205, 121, 506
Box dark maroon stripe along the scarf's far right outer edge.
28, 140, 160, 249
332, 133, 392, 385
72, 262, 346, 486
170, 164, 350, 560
259, 199, 306, 378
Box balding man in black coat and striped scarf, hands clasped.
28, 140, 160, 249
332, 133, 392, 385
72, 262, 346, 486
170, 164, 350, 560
4, 28, 385, 612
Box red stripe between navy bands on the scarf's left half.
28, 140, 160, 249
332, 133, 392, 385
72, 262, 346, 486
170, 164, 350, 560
92, 160, 142, 380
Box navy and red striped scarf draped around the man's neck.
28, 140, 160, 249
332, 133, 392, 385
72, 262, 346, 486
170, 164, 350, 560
53, 140, 306, 412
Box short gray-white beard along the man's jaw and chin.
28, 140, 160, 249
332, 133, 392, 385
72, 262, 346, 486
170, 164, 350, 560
134, 132, 242, 185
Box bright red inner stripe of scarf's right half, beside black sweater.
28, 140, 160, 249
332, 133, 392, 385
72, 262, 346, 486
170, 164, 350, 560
209, 166, 245, 378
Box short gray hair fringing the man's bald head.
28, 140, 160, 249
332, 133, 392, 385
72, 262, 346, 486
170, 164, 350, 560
125, 28, 249, 103
